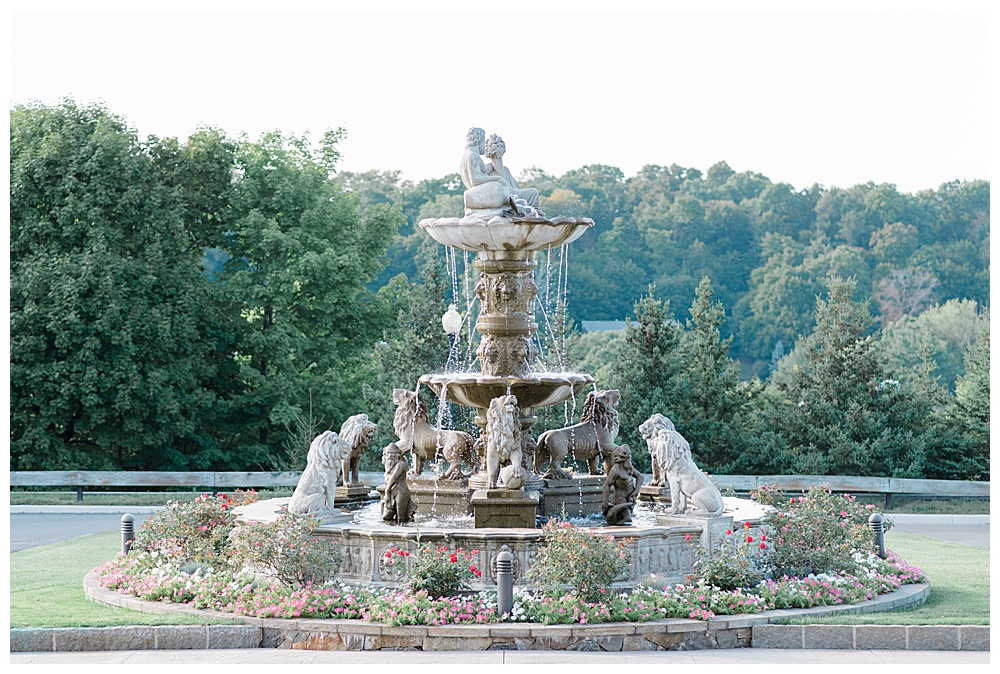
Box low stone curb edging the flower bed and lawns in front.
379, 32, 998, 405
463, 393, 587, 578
17, 572, 976, 653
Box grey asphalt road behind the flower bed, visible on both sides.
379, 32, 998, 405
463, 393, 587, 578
10, 506, 990, 553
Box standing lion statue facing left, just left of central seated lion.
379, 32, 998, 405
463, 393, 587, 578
392, 388, 474, 480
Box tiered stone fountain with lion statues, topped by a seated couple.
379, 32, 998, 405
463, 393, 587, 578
243, 128, 761, 589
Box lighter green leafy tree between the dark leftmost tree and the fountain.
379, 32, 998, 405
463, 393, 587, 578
220, 130, 403, 462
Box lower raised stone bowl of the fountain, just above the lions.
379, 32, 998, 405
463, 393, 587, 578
420, 372, 594, 410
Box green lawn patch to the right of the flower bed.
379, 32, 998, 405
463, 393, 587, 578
783, 532, 990, 625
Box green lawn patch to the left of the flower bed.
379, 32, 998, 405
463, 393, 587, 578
10, 531, 238, 627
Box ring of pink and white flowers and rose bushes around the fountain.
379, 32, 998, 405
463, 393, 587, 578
96, 490, 926, 626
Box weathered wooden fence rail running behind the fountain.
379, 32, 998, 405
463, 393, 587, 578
10, 470, 990, 509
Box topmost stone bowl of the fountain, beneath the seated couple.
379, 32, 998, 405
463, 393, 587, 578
419, 215, 594, 252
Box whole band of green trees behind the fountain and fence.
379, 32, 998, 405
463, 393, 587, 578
10, 100, 989, 477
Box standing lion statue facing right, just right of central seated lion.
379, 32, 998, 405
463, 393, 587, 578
535, 389, 621, 480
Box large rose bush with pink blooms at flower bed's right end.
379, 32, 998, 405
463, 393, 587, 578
747, 485, 892, 578
